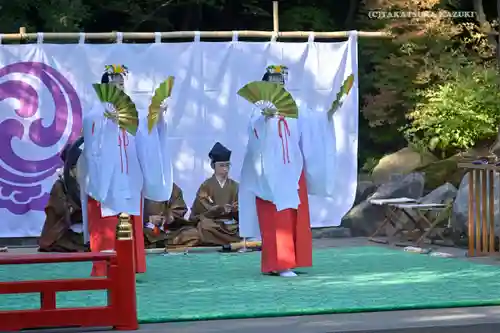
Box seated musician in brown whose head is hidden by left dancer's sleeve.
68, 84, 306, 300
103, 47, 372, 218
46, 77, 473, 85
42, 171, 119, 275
144, 183, 193, 248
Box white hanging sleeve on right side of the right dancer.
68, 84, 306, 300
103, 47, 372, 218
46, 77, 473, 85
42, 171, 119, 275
299, 105, 341, 198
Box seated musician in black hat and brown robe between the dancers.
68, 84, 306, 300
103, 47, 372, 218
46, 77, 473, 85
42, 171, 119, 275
189, 142, 240, 246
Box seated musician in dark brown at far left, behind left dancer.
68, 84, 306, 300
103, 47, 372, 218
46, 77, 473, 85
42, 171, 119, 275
38, 146, 87, 252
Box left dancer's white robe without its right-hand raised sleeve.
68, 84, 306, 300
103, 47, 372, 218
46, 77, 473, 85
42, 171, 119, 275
77, 103, 144, 242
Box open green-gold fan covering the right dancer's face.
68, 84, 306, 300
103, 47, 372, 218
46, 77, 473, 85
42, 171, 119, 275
238, 81, 299, 118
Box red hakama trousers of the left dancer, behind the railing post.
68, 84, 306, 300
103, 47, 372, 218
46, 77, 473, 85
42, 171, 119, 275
87, 196, 146, 276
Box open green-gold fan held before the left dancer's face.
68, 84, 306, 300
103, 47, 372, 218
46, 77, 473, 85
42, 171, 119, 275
92, 83, 139, 135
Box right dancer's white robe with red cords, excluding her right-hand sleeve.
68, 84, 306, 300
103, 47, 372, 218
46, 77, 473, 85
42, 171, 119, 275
238, 108, 303, 238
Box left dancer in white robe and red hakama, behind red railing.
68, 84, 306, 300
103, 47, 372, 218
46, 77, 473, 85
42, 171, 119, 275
78, 65, 172, 276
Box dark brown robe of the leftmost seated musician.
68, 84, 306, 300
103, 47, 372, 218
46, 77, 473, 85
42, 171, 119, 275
38, 179, 87, 252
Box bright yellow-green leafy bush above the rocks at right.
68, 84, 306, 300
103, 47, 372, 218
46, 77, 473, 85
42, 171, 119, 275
403, 64, 500, 157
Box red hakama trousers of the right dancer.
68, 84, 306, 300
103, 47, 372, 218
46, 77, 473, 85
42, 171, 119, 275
256, 171, 312, 273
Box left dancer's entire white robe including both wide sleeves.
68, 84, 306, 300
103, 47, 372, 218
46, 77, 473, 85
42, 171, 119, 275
77, 103, 173, 242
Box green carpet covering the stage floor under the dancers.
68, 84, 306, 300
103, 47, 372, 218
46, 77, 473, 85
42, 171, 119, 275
0, 246, 500, 323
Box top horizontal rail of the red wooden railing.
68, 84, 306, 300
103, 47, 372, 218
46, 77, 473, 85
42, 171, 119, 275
0, 252, 116, 265
